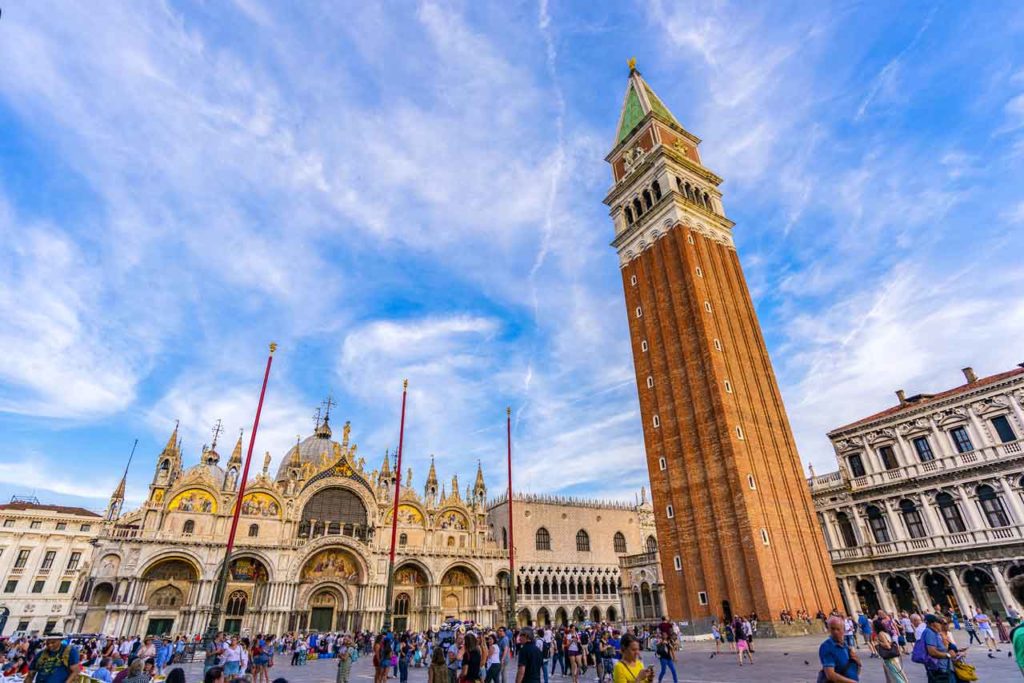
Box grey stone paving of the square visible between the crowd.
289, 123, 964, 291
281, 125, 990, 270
165, 636, 1024, 683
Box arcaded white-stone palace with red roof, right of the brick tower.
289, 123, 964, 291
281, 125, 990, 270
809, 367, 1024, 616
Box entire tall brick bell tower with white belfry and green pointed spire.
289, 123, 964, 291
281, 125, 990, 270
604, 60, 842, 635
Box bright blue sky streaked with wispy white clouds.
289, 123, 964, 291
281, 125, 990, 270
0, 0, 1024, 508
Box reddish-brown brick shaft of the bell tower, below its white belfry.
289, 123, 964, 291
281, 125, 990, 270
622, 224, 841, 623
